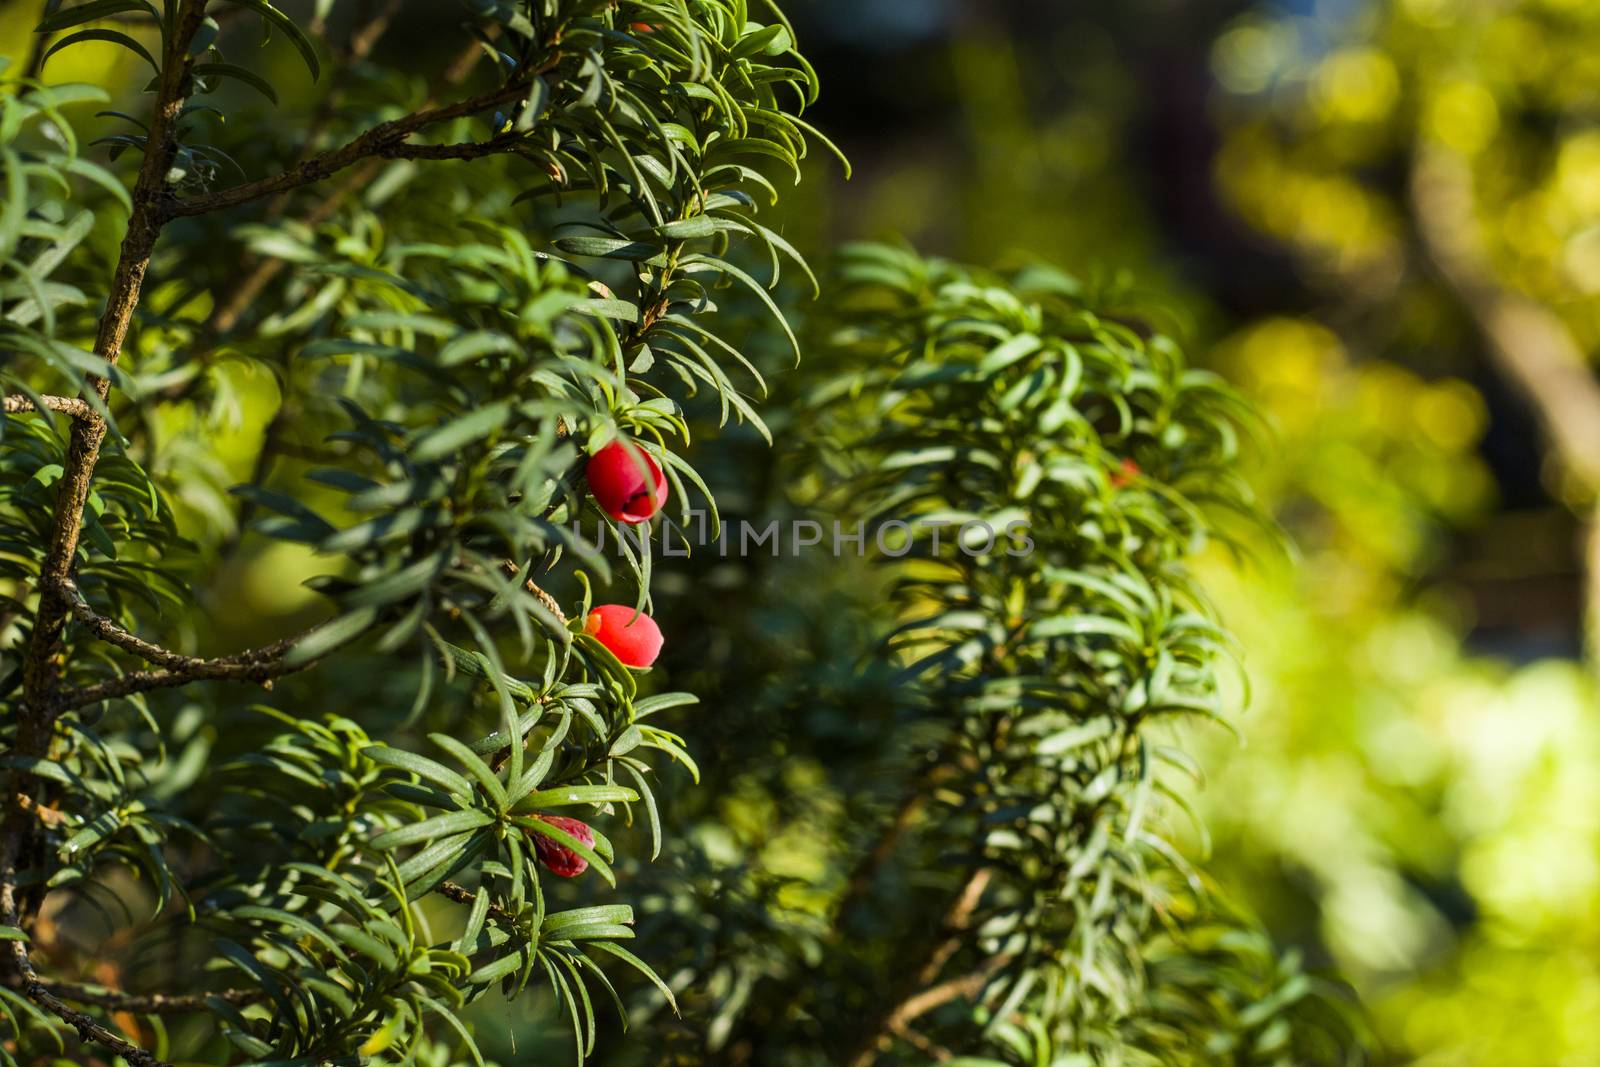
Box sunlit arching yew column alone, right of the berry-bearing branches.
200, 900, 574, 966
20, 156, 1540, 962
800, 246, 1350, 1064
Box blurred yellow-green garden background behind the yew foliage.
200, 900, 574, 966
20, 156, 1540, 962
0, 0, 1600, 1067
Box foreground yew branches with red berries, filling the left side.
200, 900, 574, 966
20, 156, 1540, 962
0, 0, 814, 1065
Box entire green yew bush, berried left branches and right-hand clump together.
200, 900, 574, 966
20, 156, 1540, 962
0, 0, 1349, 1065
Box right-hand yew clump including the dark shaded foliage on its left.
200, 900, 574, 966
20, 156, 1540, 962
579, 246, 1355, 1064
